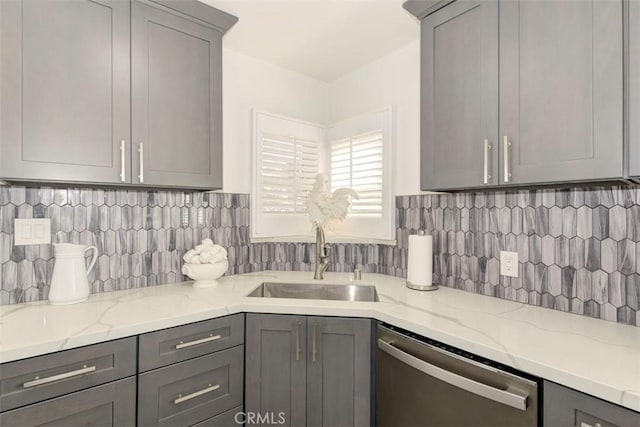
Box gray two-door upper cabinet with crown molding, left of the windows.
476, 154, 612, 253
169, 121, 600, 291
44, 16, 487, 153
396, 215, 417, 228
0, 0, 237, 189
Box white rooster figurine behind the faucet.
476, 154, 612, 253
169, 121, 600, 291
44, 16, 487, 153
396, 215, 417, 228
307, 174, 358, 227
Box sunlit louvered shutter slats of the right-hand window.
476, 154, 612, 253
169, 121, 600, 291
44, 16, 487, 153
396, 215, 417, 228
331, 129, 384, 216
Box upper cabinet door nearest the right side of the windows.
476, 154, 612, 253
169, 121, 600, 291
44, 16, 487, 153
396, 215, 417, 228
420, 0, 498, 190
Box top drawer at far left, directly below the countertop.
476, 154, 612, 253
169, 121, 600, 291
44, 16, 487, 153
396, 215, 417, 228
0, 337, 136, 412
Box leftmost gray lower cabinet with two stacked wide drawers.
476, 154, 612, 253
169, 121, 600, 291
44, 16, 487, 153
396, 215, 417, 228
0, 337, 137, 427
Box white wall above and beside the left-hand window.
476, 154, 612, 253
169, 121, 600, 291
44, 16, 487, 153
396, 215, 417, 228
222, 49, 329, 193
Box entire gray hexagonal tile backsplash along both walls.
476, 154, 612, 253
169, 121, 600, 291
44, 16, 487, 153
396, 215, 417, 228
0, 186, 640, 326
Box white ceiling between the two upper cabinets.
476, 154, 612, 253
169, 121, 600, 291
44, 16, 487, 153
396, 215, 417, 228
200, 0, 420, 82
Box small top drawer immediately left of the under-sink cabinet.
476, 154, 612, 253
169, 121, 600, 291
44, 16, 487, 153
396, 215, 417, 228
138, 314, 244, 372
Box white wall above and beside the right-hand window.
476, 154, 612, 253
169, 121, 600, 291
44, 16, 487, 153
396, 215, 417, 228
328, 41, 420, 195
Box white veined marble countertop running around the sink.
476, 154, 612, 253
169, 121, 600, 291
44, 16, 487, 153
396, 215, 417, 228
0, 271, 640, 411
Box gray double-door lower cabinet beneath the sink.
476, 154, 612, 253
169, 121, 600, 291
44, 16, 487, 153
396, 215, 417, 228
245, 314, 373, 426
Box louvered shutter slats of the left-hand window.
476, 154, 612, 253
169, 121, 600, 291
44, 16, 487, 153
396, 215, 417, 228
262, 133, 320, 213
